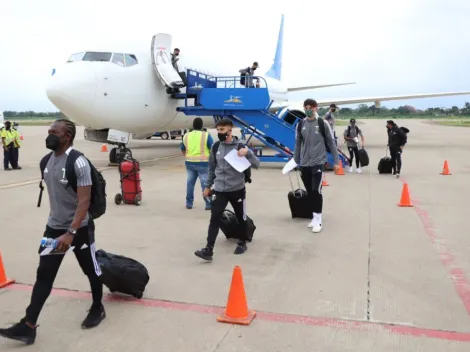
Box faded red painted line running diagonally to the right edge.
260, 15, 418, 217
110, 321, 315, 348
401, 178, 470, 316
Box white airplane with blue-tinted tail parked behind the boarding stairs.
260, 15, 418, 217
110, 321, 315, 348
46, 16, 470, 163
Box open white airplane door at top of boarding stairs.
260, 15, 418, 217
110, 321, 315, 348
152, 33, 184, 88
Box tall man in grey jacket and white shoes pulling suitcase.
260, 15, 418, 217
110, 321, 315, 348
294, 99, 339, 233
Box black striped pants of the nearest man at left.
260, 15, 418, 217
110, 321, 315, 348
26, 221, 103, 324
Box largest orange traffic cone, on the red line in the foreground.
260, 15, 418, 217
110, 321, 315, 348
217, 266, 256, 325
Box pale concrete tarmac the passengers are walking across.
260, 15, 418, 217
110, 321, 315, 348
0, 120, 470, 352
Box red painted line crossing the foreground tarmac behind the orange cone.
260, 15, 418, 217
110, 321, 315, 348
4, 283, 470, 342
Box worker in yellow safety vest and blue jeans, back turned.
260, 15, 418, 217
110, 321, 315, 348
181, 117, 214, 210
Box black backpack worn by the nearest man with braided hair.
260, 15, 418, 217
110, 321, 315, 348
38, 149, 106, 219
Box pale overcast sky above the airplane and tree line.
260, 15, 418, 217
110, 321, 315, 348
0, 0, 470, 111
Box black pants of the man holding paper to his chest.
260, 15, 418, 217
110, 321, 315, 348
207, 188, 246, 247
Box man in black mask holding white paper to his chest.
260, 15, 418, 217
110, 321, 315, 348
194, 119, 260, 261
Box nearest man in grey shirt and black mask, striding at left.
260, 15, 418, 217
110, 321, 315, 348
0, 119, 106, 344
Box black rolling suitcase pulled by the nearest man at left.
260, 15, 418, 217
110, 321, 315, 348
95, 249, 150, 299
